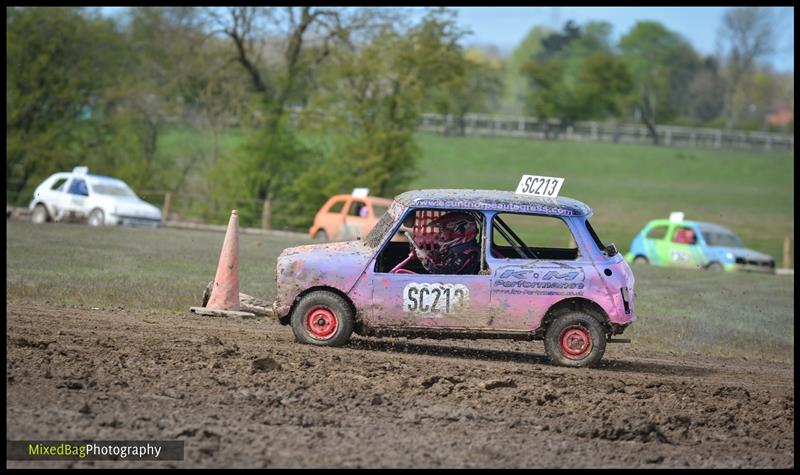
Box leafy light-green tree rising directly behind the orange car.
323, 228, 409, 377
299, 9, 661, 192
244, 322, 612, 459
286, 10, 463, 229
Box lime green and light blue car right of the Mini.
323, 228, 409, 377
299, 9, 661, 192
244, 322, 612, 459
625, 217, 775, 274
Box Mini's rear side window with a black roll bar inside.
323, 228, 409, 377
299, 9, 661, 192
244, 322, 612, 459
491, 213, 578, 260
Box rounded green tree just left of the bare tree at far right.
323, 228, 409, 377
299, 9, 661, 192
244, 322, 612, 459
619, 21, 698, 144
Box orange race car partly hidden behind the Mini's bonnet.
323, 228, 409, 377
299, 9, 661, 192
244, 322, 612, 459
308, 195, 392, 241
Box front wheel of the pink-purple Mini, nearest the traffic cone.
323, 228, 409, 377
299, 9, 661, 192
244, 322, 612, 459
291, 290, 355, 346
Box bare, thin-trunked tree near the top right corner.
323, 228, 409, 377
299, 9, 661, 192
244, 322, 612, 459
718, 7, 776, 129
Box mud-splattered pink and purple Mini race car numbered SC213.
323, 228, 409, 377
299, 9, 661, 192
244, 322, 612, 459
274, 190, 635, 366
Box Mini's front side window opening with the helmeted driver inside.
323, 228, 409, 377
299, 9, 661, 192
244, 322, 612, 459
375, 209, 484, 275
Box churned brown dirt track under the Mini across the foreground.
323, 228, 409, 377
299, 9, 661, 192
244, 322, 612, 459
6, 302, 794, 468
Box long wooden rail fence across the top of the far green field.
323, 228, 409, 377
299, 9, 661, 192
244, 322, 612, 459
418, 113, 794, 151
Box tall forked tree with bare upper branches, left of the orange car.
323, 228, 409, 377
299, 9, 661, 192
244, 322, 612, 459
206, 7, 384, 229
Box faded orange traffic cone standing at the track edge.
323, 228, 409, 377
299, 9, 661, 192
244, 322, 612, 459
189, 210, 255, 317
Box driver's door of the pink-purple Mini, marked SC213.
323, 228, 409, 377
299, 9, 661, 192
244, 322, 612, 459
368, 209, 491, 330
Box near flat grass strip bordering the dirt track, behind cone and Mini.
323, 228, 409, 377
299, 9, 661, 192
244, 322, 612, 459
6, 222, 794, 362
